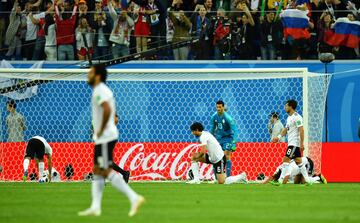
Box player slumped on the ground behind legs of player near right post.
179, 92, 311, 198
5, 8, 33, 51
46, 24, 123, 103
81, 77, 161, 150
263, 157, 327, 184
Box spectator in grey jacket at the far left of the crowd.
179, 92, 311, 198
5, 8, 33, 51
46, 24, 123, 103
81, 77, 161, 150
5, 0, 26, 60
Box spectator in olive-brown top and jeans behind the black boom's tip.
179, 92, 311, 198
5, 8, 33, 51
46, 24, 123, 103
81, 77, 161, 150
169, 0, 192, 60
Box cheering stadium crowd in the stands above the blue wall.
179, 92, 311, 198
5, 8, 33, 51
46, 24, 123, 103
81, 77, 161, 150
0, 0, 360, 60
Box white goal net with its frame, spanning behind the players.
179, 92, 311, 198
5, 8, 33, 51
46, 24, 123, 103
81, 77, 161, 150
0, 68, 330, 181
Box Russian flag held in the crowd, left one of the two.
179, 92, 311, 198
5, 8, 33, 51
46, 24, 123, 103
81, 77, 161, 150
280, 9, 310, 39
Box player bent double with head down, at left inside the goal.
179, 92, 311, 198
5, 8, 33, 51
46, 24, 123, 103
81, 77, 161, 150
23, 136, 52, 182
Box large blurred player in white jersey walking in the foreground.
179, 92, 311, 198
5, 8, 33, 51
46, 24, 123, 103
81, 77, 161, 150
78, 64, 145, 217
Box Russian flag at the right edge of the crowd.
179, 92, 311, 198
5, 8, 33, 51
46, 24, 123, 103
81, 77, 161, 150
325, 17, 360, 49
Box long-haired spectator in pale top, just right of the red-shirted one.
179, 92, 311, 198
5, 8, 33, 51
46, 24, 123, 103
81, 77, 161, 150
75, 16, 94, 60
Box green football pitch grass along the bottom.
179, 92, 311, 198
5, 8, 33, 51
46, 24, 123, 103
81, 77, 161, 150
0, 182, 360, 223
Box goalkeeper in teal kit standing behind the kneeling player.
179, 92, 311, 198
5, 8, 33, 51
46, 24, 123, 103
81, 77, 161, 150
210, 101, 238, 177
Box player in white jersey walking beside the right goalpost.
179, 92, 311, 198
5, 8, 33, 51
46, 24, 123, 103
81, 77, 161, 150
273, 100, 311, 185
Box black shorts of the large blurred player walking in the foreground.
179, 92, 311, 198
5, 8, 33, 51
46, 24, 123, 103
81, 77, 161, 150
94, 140, 117, 169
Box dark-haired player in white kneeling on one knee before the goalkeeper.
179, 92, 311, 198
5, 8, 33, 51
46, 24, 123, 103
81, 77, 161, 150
187, 122, 246, 184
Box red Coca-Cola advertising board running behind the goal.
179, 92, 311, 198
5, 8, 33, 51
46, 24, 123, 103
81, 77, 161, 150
0, 143, 360, 182
